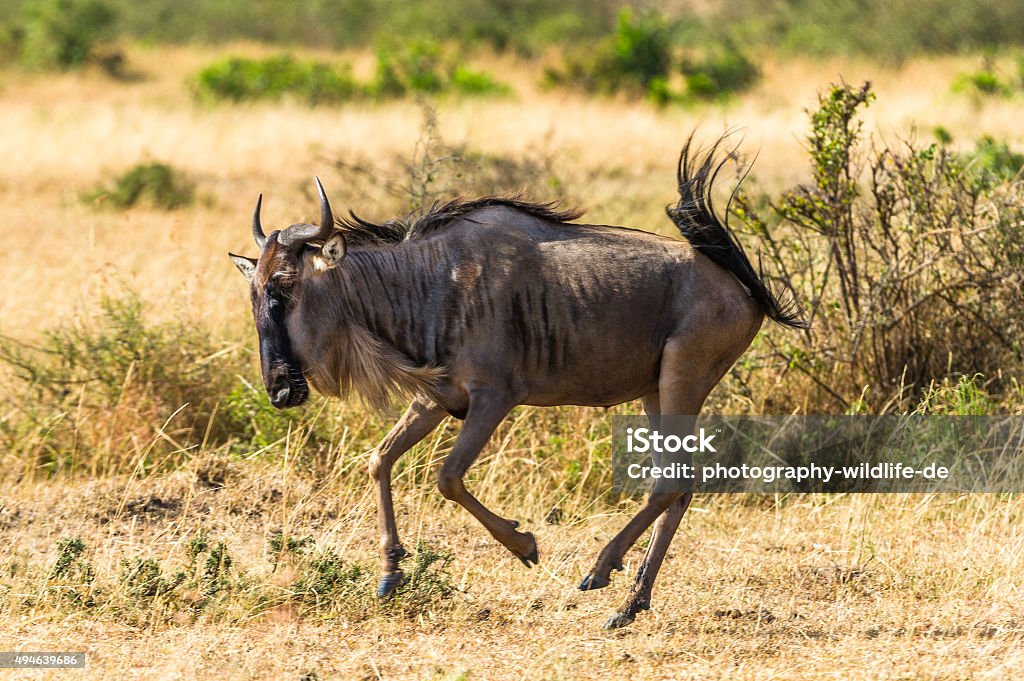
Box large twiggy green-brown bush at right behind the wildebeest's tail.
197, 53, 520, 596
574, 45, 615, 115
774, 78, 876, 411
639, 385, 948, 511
734, 79, 1024, 412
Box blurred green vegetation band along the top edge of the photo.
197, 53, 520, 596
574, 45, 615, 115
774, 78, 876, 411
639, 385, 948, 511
6, 0, 1024, 59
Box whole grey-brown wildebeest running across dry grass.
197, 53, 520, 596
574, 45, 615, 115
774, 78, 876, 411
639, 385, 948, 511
231, 138, 803, 628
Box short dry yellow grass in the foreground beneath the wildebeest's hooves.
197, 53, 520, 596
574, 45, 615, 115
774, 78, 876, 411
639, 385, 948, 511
0, 462, 1024, 679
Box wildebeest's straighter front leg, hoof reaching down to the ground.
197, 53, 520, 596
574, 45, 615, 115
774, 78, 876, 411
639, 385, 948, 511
370, 397, 447, 598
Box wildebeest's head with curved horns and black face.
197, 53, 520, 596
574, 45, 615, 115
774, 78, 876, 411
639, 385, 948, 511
228, 178, 345, 409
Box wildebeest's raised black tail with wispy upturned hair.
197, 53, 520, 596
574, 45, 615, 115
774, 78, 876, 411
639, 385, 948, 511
666, 135, 807, 329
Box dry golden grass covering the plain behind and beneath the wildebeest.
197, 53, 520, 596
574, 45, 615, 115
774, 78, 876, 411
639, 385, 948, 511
0, 46, 1024, 679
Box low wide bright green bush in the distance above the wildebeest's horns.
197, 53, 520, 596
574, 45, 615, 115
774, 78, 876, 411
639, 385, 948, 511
195, 54, 364, 105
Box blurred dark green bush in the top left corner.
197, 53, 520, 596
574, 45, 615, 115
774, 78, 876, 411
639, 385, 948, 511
9, 0, 115, 71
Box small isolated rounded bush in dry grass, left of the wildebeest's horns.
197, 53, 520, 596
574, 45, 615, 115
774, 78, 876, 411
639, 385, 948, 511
83, 161, 196, 210
